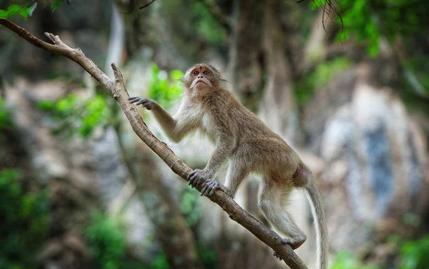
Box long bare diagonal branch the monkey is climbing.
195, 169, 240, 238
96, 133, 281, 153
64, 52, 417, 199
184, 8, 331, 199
0, 19, 307, 269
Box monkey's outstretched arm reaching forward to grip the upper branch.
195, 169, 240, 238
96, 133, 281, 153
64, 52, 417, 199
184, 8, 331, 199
129, 97, 197, 143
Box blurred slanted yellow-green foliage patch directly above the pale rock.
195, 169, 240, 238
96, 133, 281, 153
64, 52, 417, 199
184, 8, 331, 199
295, 57, 351, 104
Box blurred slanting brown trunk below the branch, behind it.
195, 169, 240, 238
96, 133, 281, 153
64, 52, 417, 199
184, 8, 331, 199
133, 145, 203, 269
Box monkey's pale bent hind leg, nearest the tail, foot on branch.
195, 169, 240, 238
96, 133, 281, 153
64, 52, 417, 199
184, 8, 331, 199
259, 179, 307, 252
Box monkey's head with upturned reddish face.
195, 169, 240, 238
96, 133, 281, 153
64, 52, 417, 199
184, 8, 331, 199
182, 64, 225, 91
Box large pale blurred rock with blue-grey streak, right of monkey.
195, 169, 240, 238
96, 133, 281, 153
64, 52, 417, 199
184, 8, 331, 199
305, 67, 428, 250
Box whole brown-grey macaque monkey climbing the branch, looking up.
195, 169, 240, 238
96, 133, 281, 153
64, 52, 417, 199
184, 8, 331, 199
129, 64, 327, 269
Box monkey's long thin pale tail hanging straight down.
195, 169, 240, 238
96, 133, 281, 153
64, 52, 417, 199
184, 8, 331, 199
305, 179, 328, 269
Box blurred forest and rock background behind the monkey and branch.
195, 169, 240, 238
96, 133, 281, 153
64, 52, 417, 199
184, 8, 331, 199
0, 0, 429, 269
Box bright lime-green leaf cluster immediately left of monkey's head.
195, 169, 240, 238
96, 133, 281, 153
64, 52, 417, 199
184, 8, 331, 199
149, 64, 183, 108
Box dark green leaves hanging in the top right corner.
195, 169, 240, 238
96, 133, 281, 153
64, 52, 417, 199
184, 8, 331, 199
337, 0, 429, 56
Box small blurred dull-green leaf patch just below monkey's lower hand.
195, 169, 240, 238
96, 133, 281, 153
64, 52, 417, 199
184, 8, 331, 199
180, 188, 203, 226
